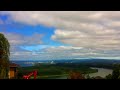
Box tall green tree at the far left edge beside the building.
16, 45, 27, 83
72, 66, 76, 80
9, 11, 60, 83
0, 33, 10, 79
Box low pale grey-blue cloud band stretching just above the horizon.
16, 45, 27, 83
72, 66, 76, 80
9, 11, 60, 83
10, 46, 120, 60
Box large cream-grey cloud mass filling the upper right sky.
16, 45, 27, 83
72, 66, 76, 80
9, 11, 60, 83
1, 11, 120, 49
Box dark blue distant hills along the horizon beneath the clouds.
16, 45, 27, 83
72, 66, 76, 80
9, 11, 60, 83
11, 59, 120, 66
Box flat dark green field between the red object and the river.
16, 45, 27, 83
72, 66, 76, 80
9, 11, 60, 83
18, 64, 97, 79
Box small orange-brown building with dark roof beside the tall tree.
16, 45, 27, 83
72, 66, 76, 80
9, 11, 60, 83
8, 63, 19, 79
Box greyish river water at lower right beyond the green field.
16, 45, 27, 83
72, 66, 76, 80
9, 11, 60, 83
89, 67, 113, 77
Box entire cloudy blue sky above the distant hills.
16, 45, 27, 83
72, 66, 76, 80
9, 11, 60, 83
0, 11, 120, 60
